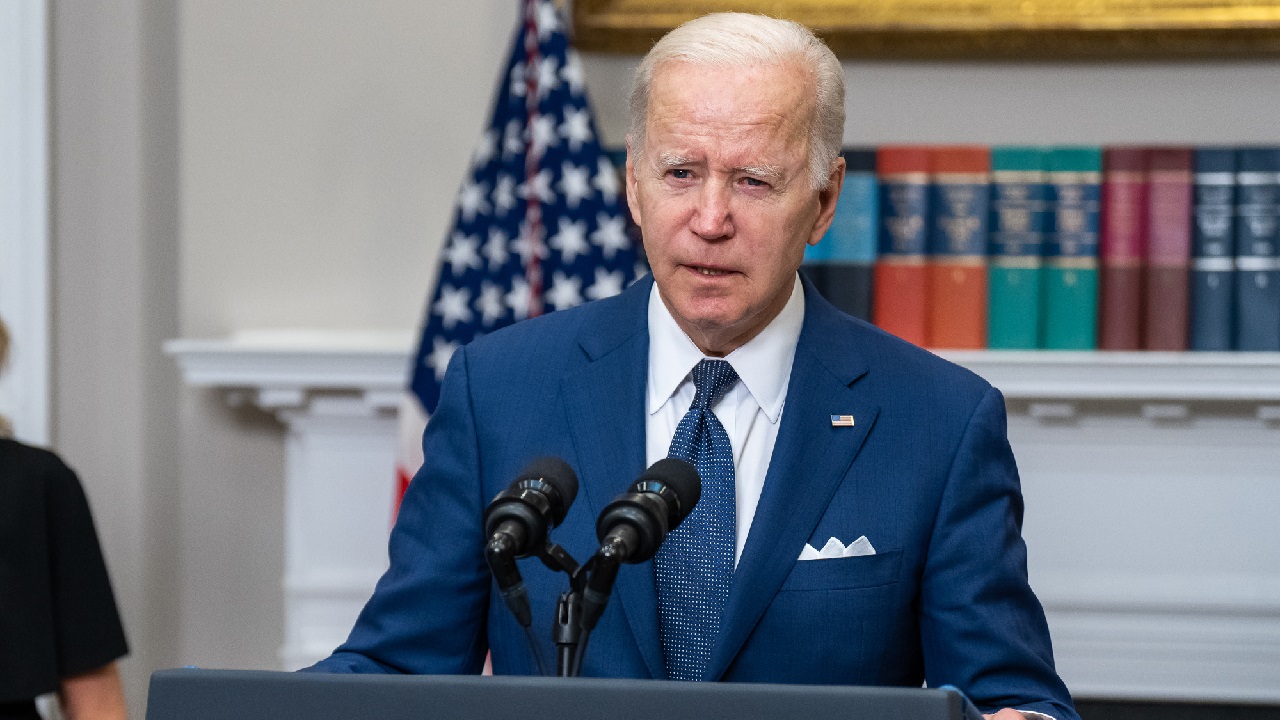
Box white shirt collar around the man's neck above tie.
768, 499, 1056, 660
648, 275, 804, 423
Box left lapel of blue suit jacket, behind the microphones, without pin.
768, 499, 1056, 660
561, 272, 666, 678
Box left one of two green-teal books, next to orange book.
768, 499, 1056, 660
987, 146, 1048, 350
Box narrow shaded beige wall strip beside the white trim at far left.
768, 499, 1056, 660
50, 0, 180, 708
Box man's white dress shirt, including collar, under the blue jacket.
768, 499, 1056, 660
645, 277, 804, 564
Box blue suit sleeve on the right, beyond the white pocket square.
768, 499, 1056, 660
919, 388, 1078, 720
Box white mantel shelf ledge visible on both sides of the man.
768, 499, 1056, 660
165, 331, 1280, 407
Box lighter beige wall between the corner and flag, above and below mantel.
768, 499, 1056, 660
177, 0, 516, 669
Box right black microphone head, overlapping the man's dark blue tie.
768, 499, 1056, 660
595, 457, 703, 562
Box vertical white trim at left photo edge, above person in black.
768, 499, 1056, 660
0, 0, 50, 445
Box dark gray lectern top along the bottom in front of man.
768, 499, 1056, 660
147, 669, 982, 720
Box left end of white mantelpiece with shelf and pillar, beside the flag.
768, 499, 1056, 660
164, 331, 412, 670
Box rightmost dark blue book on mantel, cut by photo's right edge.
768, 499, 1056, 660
1235, 147, 1280, 351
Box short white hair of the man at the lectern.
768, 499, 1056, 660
628, 13, 845, 190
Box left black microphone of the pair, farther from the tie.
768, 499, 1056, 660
484, 457, 577, 628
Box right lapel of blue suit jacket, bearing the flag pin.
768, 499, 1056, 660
707, 283, 878, 680
